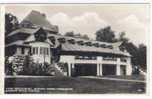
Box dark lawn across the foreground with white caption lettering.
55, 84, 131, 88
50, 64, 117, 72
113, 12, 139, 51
5, 77, 146, 94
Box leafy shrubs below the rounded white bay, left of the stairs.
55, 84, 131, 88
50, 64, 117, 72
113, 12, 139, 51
5, 55, 54, 76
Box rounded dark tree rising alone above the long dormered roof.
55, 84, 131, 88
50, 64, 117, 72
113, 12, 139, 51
96, 26, 116, 43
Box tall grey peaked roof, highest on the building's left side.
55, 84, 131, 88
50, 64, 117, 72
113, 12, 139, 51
20, 10, 58, 32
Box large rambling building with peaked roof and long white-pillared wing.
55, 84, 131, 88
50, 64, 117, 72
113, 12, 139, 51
5, 11, 132, 76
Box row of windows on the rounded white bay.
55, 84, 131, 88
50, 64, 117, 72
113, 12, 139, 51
32, 47, 49, 55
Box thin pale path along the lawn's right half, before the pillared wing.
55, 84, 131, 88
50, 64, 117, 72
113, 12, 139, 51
80, 76, 146, 83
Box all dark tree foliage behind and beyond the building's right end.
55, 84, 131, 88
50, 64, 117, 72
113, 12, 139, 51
96, 26, 147, 70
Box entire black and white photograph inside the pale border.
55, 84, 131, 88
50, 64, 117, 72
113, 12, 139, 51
4, 3, 150, 95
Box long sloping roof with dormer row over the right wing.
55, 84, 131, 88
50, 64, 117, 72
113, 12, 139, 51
48, 34, 130, 56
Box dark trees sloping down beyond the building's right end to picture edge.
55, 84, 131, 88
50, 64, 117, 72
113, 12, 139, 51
118, 32, 147, 70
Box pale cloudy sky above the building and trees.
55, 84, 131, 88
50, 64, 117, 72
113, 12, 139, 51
5, 4, 150, 45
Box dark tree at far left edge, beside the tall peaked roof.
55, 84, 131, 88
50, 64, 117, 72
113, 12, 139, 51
5, 13, 19, 35
